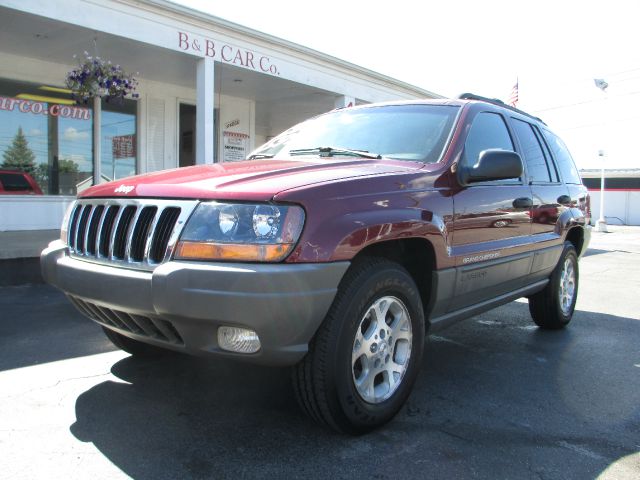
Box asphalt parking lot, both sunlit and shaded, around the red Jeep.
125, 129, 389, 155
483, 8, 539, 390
0, 227, 640, 480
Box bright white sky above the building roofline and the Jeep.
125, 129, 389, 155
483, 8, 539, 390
173, 0, 640, 169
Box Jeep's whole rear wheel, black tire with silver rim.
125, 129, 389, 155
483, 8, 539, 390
529, 242, 579, 330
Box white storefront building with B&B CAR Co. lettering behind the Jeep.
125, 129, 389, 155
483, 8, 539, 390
0, 0, 437, 232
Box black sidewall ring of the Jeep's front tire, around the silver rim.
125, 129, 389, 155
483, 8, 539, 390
332, 264, 425, 431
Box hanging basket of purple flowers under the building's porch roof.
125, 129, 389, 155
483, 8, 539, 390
65, 52, 138, 105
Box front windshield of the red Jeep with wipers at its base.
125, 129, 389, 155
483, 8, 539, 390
249, 105, 459, 163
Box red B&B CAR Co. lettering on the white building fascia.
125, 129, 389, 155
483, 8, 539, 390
178, 32, 280, 75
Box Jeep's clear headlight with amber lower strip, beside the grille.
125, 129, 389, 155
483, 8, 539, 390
175, 202, 304, 262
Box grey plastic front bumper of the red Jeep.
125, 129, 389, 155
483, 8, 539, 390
41, 240, 349, 365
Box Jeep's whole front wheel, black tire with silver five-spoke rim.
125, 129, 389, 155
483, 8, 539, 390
293, 259, 425, 434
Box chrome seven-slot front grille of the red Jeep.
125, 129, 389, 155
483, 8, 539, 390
67, 199, 197, 270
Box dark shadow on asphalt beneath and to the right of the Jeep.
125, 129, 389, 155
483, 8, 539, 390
71, 303, 640, 479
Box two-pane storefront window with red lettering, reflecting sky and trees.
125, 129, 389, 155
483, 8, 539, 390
0, 79, 137, 195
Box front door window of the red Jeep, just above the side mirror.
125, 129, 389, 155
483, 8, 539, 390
464, 112, 514, 166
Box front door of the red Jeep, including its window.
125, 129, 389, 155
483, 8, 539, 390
449, 112, 532, 311
